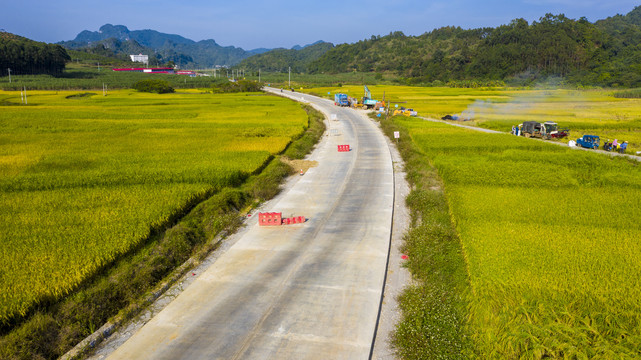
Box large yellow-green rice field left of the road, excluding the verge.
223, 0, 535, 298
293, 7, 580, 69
0, 90, 307, 322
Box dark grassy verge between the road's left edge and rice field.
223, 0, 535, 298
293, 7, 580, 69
0, 102, 325, 359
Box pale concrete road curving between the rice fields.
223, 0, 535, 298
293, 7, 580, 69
109, 88, 394, 359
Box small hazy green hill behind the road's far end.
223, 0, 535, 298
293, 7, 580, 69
238, 41, 334, 72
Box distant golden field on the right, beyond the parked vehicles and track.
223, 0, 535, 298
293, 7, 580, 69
302, 85, 641, 152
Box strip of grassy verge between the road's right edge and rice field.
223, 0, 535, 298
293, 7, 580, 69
380, 114, 474, 359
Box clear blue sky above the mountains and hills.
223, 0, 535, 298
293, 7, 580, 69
0, 0, 641, 50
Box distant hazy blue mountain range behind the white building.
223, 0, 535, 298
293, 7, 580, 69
58, 24, 331, 68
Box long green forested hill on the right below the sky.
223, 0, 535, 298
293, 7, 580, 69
307, 7, 641, 87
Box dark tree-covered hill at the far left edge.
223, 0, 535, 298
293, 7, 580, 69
0, 31, 70, 76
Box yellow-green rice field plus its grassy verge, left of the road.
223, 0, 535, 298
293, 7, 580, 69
0, 91, 323, 359
